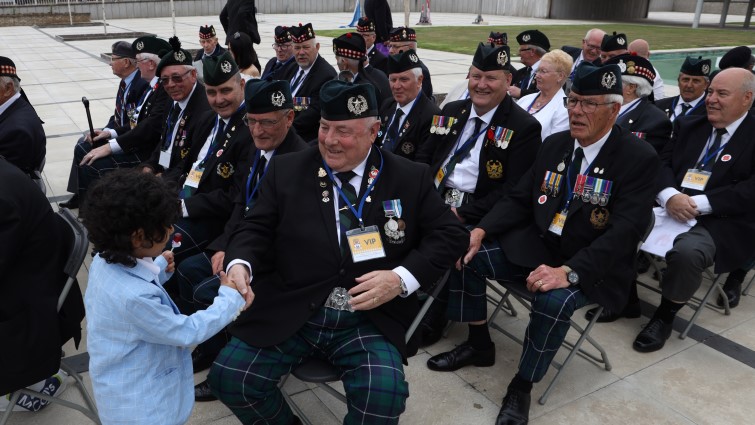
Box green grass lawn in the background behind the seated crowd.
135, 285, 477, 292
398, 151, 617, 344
317, 24, 755, 54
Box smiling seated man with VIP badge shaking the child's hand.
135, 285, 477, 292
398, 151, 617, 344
208, 80, 467, 424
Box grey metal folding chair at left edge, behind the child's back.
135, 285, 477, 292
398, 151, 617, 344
0, 208, 101, 425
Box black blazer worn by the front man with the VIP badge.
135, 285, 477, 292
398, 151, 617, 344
225, 147, 469, 357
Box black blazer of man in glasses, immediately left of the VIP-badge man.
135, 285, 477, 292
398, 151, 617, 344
207, 127, 308, 252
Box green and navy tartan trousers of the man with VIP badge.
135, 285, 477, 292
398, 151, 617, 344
207, 307, 409, 425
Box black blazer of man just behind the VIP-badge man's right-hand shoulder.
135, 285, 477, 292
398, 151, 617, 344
375, 96, 440, 160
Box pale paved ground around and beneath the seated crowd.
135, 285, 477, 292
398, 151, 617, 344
0, 9, 755, 425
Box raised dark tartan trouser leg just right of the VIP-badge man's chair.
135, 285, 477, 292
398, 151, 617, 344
446, 239, 530, 322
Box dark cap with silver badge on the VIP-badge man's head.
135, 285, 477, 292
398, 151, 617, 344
320, 80, 378, 121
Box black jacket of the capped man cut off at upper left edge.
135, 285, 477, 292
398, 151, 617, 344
0, 96, 47, 174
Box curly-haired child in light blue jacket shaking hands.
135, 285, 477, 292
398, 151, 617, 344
83, 170, 254, 424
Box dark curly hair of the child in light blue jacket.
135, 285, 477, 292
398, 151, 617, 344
82, 169, 181, 267
